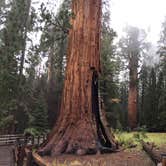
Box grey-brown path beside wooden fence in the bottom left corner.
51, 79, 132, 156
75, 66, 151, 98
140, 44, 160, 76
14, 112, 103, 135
0, 146, 14, 166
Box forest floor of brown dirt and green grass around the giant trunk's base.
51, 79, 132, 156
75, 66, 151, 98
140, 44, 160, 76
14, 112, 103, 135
34, 132, 166, 166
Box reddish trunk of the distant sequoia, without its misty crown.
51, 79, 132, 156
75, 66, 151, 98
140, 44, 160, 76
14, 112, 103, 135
128, 55, 138, 129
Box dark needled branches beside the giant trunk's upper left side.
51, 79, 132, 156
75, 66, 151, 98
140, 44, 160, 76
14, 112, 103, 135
40, 0, 72, 52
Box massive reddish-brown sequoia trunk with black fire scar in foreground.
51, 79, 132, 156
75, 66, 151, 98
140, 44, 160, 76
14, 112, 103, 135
41, 0, 116, 155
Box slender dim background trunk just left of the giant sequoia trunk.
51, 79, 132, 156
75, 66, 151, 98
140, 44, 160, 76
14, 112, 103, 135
47, 36, 66, 127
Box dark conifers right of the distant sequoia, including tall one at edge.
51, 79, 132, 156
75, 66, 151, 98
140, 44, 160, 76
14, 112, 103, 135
140, 17, 166, 131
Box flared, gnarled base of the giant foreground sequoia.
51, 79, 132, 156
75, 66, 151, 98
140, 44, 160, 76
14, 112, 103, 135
38, 115, 118, 156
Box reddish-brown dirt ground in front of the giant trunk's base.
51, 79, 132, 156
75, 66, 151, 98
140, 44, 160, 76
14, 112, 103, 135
42, 150, 155, 166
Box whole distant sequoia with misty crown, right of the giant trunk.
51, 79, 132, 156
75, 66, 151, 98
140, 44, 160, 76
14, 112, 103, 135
120, 26, 146, 129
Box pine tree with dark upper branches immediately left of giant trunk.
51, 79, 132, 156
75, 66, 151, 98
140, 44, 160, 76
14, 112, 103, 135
40, 0, 71, 127
